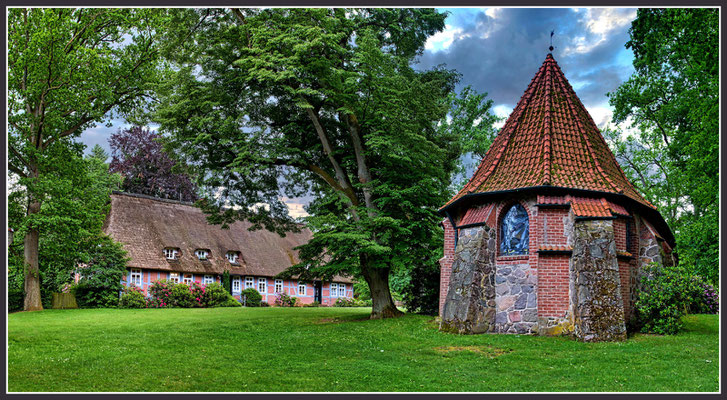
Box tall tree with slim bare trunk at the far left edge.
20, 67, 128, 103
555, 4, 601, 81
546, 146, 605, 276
8, 8, 158, 310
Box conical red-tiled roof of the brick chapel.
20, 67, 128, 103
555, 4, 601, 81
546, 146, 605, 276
443, 54, 655, 209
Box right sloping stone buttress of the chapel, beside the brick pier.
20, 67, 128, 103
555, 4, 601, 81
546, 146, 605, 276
571, 220, 626, 341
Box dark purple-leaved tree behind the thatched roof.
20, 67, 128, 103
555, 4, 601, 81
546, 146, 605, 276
109, 126, 197, 201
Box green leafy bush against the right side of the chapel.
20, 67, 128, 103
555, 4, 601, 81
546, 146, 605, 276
635, 263, 695, 335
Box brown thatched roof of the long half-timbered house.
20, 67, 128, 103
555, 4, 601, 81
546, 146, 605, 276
104, 192, 351, 283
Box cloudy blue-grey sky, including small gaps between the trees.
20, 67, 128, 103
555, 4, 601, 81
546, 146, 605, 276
80, 8, 636, 216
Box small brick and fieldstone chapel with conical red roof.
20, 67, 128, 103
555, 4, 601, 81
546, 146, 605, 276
439, 54, 675, 341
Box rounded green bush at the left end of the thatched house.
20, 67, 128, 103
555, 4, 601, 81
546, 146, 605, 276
73, 235, 128, 308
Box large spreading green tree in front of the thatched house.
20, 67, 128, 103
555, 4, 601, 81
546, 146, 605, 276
155, 8, 490, 318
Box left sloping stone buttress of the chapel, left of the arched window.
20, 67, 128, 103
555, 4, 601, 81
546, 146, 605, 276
439, 226, 496, 334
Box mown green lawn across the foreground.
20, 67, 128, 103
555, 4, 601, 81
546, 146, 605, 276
8, 308, 719, 392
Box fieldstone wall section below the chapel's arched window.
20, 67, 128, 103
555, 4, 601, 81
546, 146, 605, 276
495, 264, 538, 333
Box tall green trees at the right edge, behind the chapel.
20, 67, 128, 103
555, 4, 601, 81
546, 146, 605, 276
610, 8, 719, 283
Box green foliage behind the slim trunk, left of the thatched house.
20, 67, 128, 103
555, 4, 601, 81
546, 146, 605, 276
8, 144, 121, 305
